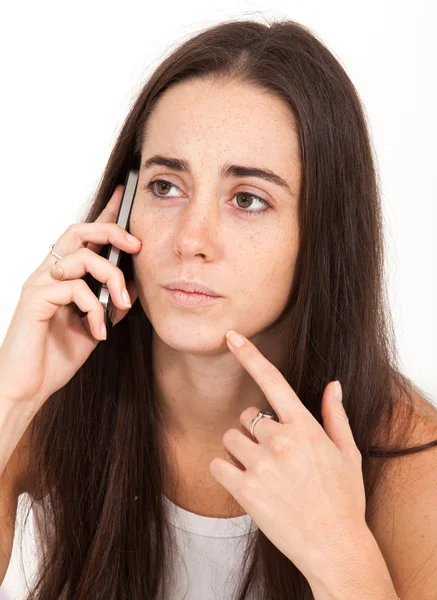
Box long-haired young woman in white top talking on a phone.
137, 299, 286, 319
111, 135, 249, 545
0, 16, 437, 600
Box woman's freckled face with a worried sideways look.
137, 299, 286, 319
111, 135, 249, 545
130, 79, 300, 354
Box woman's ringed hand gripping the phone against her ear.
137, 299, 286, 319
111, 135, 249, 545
0, 185, 141, 414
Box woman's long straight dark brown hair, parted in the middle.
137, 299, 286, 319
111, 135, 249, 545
22, 20, 437, 600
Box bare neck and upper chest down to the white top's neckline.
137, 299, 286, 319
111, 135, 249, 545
152, 322, 288, 518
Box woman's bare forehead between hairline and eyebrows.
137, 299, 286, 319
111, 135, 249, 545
144, 79, 299, 163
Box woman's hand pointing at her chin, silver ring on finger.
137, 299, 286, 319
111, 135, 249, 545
209, 332, 370, 580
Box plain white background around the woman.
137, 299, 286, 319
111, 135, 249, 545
0, 0, 437, 598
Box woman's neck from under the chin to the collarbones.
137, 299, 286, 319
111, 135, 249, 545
152, 324, 280, 447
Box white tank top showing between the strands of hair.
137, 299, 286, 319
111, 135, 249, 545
0, 494, 257, 600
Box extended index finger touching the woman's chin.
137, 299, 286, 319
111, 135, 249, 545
226, 331, 306, 423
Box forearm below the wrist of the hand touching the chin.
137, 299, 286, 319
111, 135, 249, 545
308, 530, 398, 600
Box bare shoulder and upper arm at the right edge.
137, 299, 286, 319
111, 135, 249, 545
369, 394, 437, 600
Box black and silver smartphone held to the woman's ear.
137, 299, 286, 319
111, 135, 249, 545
76, 169, 139, 335
